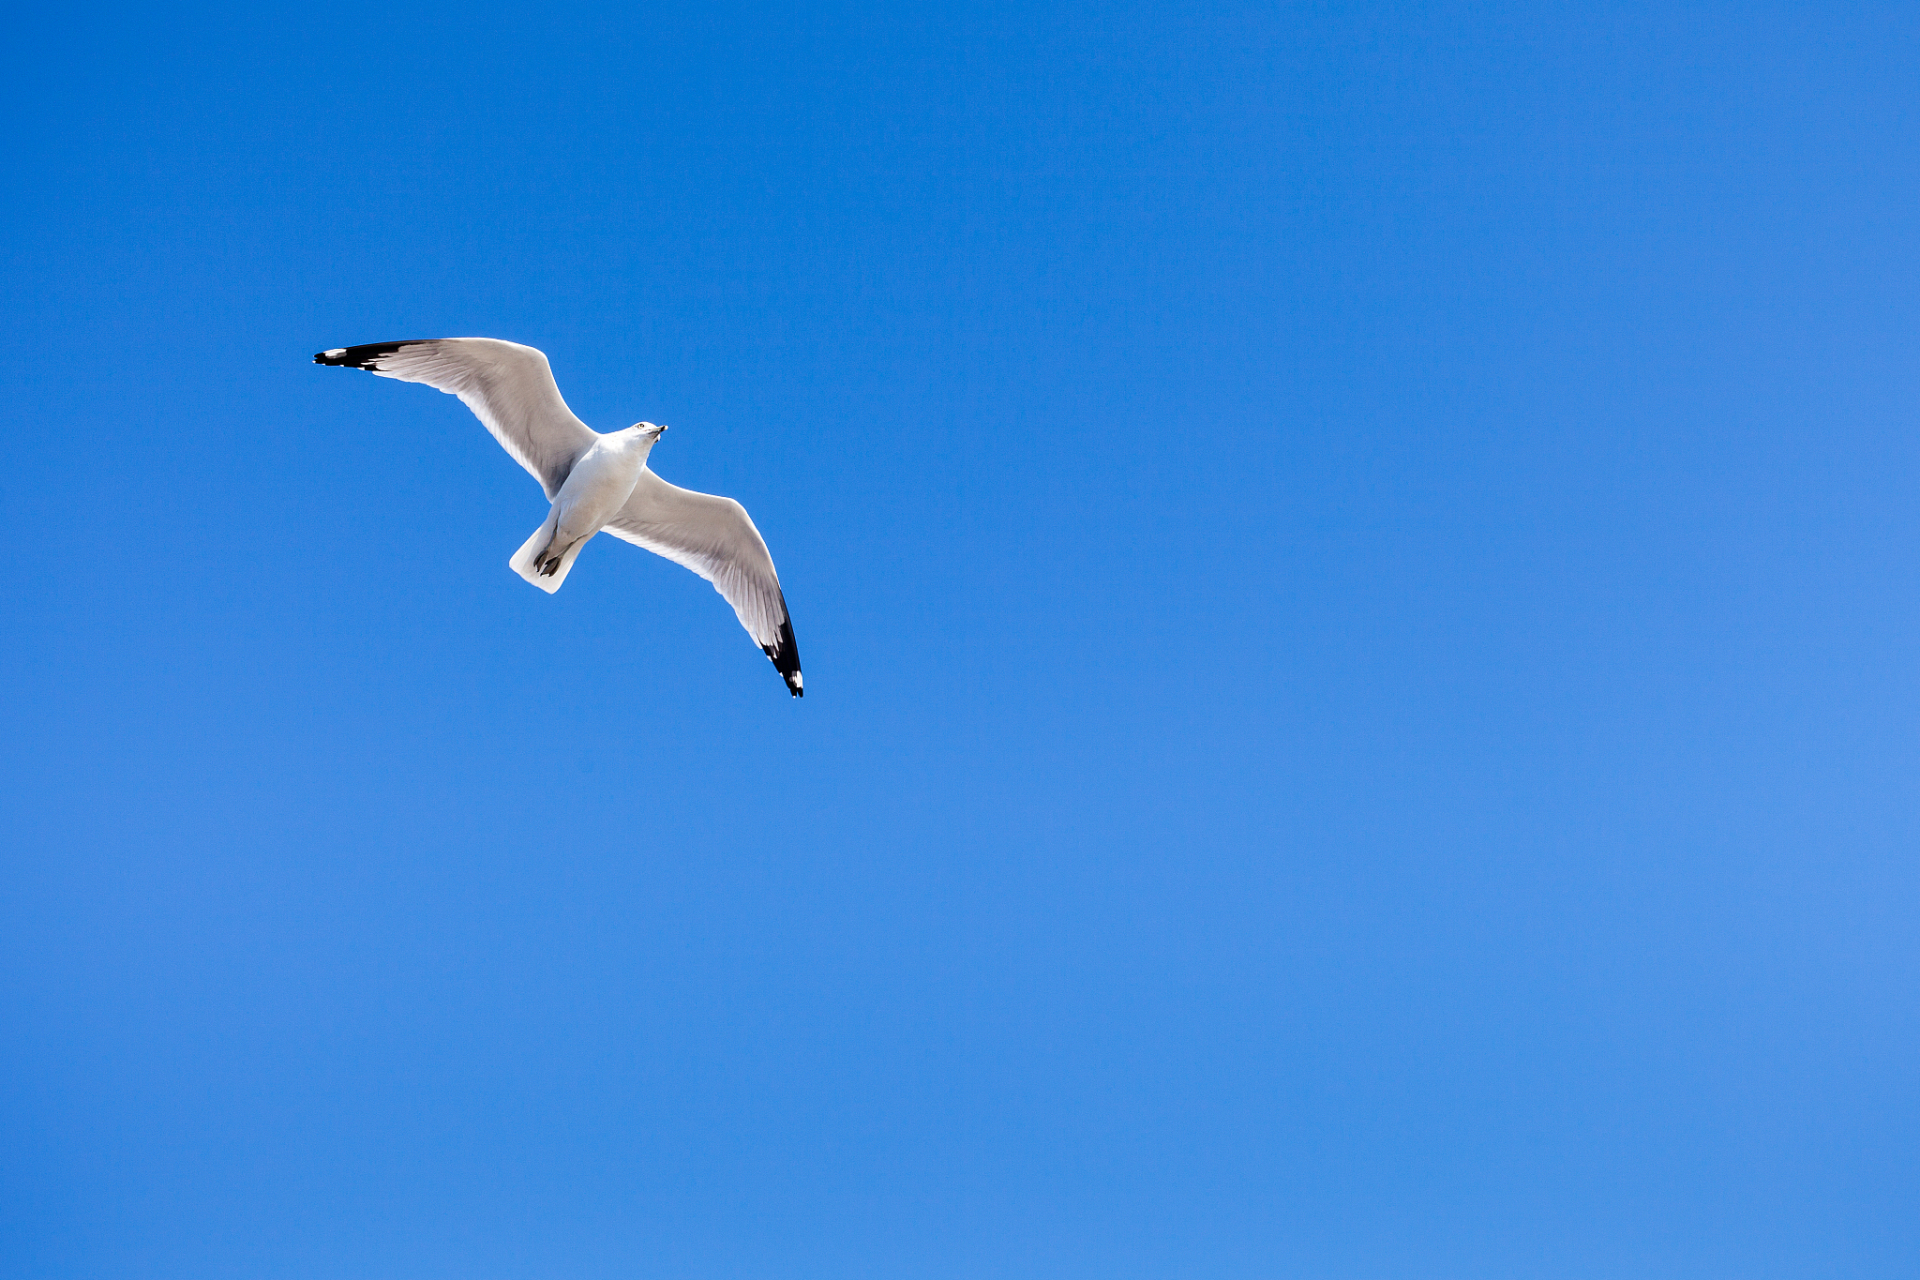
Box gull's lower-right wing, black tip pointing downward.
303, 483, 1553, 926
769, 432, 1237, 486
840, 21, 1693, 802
607, 470, 803, 699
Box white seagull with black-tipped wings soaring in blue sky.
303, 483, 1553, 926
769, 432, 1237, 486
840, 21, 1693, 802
313, 338, 804, 699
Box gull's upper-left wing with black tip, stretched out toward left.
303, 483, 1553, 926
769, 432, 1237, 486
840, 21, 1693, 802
313, 338, 595, 501
